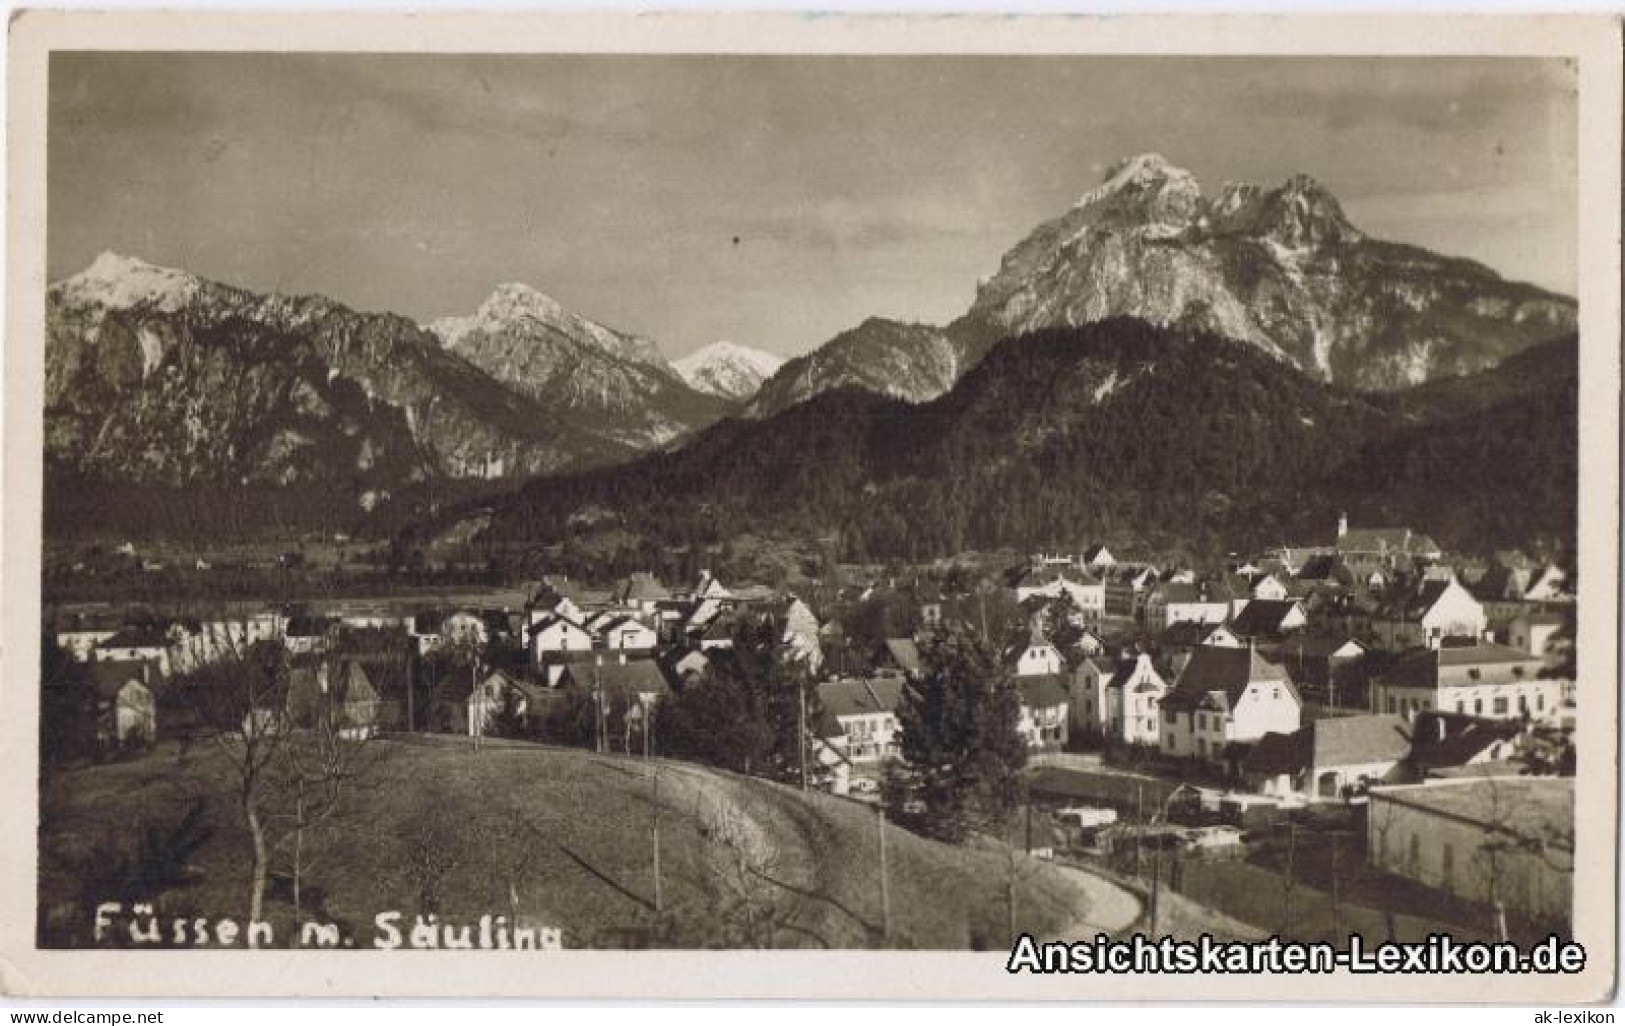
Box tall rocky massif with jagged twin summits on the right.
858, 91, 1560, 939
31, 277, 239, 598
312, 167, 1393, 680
749, 153, 1576, 416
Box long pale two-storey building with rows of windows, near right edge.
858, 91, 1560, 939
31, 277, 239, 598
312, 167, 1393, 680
1370, 644, 1563, 720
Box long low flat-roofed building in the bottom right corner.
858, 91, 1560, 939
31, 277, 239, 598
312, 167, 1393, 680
1367, 777, 1575, 928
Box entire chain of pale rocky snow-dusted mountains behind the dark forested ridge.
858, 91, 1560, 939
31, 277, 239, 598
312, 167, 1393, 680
46, 154, 1576, 540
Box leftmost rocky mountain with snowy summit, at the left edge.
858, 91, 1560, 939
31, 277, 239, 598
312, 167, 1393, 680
46, 254, 676, 502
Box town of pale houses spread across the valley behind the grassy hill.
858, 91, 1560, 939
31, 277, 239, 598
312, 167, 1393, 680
41, 515, 1583, 938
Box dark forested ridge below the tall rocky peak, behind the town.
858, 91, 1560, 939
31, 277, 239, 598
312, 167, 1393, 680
491, 317, 1578, 559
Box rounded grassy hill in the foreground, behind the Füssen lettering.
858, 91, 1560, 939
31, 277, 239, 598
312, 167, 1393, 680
39, 738, 1131, 950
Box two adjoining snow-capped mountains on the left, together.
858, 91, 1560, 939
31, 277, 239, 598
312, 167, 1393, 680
46, 254, 733, 504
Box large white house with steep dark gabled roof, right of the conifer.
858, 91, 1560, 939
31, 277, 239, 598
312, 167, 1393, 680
1162, 646, 1303, 764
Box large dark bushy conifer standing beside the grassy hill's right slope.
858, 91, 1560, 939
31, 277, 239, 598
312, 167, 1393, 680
889, 628, 1027, 842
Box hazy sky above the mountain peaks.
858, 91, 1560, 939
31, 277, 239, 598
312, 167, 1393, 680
47, 52, 1578, 356
